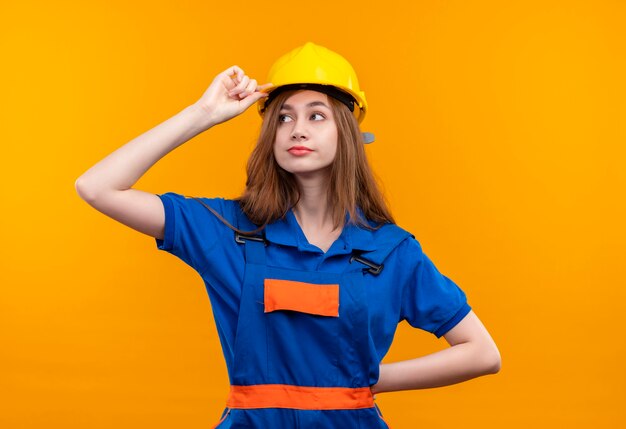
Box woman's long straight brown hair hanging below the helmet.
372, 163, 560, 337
193, 91, 395, 233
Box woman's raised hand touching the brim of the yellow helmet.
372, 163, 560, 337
195, 66, 272, 126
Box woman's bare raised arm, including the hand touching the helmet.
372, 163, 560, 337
75, 66, 270, 239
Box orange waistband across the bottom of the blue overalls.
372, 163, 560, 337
226, 384, 374, 410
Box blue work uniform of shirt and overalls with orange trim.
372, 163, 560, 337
156, 193, 470, 429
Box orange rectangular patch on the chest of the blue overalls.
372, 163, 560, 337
264, 279, 339, 317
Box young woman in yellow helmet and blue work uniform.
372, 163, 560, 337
76, 43, 500, 429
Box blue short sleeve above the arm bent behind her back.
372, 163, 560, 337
402, 239, 471, 338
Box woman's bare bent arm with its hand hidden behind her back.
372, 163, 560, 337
372, 311, 500, 394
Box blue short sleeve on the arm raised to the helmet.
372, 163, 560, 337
155, 192, 233, 273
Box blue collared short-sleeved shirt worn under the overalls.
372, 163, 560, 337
156, 192, 471, 378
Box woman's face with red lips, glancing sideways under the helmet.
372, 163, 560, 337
274, 90, 337, 175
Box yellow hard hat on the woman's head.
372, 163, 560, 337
258, 42, 367, 123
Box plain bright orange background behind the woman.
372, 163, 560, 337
0, 0, 626, 429
